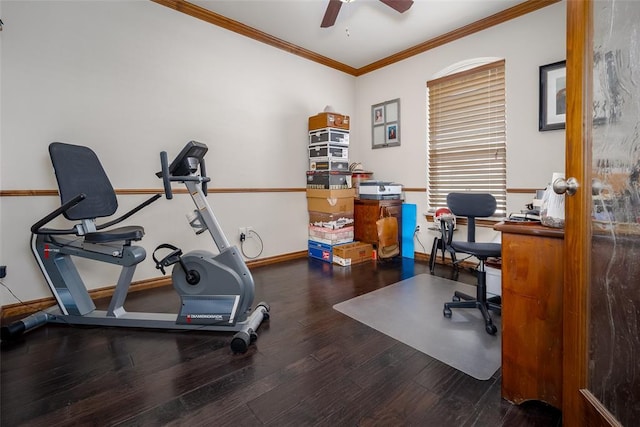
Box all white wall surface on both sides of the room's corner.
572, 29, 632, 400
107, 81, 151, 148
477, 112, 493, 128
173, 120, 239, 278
0, 1, 565, 304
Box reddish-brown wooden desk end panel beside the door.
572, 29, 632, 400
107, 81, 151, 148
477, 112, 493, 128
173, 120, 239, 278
495, 222, 564, 408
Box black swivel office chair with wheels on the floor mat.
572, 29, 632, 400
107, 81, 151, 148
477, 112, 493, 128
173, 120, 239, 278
443, 193, 502, 335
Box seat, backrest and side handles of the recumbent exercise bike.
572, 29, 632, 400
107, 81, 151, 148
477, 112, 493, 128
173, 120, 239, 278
31, 142, 160, 243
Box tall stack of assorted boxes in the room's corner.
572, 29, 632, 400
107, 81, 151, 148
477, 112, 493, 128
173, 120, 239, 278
307, 112, 371, 265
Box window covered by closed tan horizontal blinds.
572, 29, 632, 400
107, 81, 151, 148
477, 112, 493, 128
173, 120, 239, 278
427, 60, 507, 216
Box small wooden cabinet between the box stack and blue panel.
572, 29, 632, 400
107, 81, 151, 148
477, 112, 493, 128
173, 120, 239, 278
353, 199, 402, 256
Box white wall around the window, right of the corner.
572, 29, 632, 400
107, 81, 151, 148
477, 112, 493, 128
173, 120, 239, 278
349, 2, 566, 247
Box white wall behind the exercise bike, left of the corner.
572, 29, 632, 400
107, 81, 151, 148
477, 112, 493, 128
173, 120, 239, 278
0, 1, 355, 304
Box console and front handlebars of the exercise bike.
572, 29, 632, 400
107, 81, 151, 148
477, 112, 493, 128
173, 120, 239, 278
156, 141, 210, 199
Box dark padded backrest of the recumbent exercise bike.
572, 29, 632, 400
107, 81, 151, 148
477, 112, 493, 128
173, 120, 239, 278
49, 142, 118, 220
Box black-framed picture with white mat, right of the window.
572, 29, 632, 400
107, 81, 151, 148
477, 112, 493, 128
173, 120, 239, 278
538, 61, 567, 131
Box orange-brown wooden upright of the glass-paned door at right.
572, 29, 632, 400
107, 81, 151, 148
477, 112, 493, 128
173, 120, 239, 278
562, 0, 620, 427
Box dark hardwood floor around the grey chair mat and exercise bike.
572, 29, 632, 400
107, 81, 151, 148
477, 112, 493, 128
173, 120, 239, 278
0, 258, 561, 427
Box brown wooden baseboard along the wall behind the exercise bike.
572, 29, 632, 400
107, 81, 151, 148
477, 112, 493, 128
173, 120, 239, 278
0, 251, 308, 320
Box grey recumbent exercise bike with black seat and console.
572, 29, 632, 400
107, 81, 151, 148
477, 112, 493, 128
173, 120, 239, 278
2, 141, 270, 353
